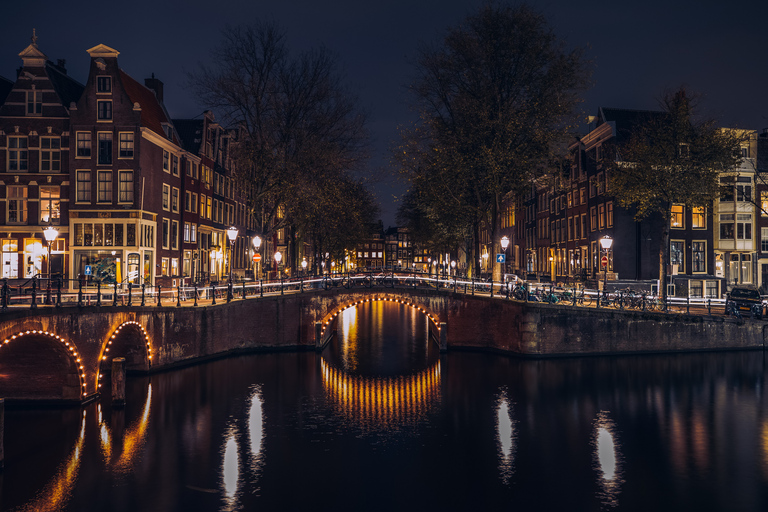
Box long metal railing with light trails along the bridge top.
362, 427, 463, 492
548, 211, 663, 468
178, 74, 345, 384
0, 272, 744, 315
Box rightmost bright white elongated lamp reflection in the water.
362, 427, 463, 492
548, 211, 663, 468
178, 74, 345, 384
592, 411, 624, 507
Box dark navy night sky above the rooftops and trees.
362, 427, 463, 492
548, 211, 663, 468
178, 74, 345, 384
0, 0, 768, 226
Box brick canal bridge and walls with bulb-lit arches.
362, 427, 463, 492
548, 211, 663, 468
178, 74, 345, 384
0, 286, 768, 403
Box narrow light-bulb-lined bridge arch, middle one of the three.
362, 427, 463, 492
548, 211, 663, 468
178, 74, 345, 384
96, 320, 152, 390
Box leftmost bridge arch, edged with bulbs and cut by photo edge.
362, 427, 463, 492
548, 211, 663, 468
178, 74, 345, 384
0, 329, 88, 402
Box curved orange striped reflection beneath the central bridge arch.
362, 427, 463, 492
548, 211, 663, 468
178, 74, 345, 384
320, 358, 441, 428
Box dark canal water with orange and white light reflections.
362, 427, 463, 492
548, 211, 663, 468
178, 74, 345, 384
0, 302, 768, 511
